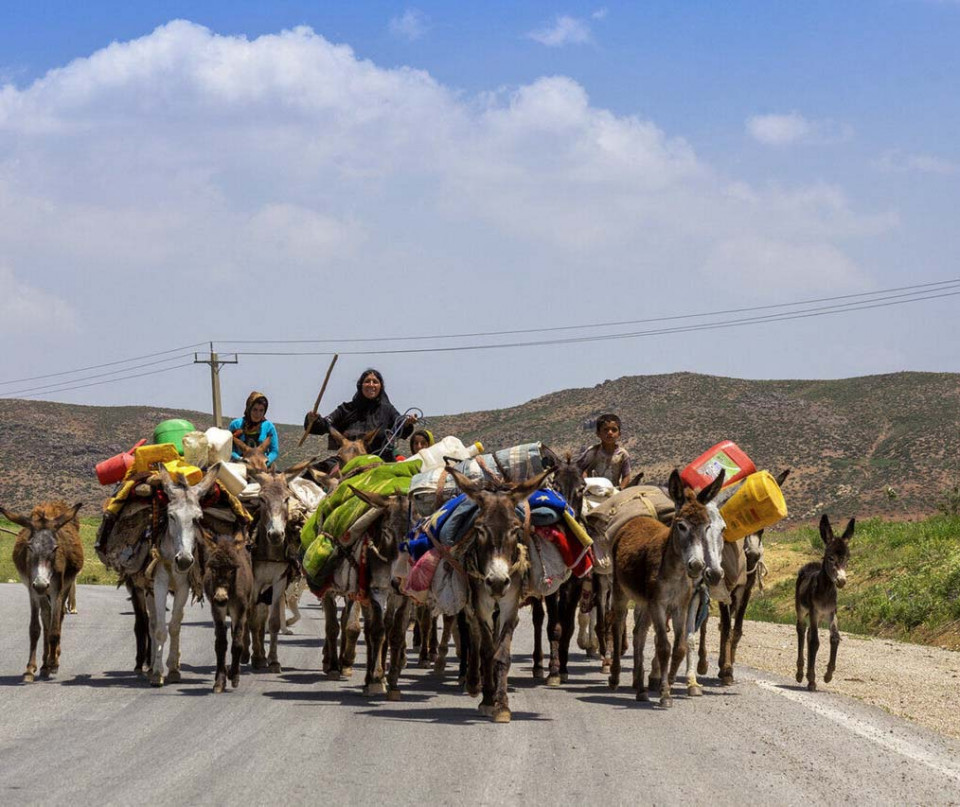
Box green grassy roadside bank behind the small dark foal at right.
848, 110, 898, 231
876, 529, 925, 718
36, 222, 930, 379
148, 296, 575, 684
747, 516, 960, 649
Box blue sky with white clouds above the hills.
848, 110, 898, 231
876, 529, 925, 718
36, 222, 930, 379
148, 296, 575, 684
0, 0, 960, 420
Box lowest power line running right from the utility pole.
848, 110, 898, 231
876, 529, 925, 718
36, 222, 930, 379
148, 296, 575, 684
237, 289, 960, 356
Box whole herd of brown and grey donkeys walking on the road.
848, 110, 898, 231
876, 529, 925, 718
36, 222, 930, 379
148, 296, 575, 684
0, 426, 854, 723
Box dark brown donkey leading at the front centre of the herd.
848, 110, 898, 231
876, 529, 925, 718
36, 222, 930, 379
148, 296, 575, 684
449, 468, 553, 723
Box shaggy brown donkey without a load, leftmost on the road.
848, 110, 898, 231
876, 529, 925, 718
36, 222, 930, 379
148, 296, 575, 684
0, 501, 83, 683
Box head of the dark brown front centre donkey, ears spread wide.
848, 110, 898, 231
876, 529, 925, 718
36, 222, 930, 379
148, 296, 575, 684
447, 468, 553, 599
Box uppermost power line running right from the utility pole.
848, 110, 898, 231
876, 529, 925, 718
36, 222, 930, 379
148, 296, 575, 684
216, 278, 960, 348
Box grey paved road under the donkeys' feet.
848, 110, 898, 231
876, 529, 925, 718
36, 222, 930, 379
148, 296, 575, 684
0, 585, 960, 806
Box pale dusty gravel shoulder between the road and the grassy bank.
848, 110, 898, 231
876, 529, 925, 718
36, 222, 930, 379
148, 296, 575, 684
707, 618, 960, 739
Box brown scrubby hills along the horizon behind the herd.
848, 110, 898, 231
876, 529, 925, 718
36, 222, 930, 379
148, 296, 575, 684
0, 372, 960, 520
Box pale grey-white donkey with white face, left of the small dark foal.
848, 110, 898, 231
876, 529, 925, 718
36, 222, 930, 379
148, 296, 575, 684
146, 462, 220, 687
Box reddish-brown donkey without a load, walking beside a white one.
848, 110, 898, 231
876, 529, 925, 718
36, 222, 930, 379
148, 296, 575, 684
609, 469, 724, 707
